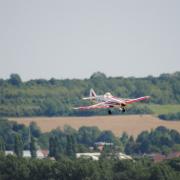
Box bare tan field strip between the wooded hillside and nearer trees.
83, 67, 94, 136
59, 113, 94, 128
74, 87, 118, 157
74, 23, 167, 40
10, 115, 180, 137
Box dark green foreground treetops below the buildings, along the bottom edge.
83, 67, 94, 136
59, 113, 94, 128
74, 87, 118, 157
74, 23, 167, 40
0, 153, 180, 180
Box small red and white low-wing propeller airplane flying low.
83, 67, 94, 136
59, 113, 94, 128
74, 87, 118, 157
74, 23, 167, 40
74, 89, 150, 114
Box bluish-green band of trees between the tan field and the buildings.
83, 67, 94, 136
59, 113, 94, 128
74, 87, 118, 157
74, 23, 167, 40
0, 119, 180, 159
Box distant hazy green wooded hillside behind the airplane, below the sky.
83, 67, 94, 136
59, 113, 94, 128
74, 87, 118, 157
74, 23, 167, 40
0, 72, 180, 116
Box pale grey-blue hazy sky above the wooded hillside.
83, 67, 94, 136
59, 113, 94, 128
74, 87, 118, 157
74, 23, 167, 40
0, 0, 180, 80
